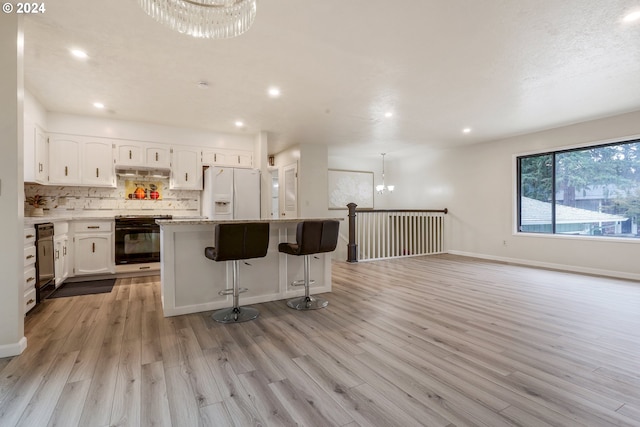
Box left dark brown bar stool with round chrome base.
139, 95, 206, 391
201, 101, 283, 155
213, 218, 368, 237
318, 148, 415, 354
204, 222, 269, 323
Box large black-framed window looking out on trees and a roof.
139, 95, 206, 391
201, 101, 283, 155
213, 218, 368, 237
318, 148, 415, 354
517, 140, 640, 238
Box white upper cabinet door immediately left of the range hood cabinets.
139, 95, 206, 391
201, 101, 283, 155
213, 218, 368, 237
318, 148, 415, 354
81, 141, 116, 187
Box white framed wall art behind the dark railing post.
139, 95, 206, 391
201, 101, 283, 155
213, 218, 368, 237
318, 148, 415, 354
328, 169, 373, 209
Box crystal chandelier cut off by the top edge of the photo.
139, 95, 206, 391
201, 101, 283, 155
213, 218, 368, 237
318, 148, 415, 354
138, 0, 256, 39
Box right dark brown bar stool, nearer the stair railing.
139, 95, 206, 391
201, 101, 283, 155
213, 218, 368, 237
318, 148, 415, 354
278, 219, 340, 310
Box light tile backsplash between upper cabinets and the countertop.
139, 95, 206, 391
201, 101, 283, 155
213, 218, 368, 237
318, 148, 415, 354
24, 177, 201, 217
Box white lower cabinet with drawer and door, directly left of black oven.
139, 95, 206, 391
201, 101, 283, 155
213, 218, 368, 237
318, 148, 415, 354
73, 220, 116, 276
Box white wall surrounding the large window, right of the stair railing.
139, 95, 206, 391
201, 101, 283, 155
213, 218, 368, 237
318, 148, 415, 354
393, 108, 640, 279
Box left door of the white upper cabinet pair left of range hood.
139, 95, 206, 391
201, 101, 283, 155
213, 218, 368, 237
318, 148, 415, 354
49, 135, 82, 185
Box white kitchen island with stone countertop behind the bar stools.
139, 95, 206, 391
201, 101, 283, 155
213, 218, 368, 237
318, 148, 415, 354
156, 218, 342, 317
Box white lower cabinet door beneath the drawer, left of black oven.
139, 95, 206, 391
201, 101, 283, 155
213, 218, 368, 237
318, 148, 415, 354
74, 233, 115, 276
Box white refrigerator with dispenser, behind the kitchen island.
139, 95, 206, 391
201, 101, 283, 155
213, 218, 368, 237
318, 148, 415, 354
202, 166, 260, 219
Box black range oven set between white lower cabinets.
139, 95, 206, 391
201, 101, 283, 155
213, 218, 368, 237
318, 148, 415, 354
115, 215, 171, 265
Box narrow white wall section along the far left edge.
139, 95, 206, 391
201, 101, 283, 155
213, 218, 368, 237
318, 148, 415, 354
0, 14, 26, 357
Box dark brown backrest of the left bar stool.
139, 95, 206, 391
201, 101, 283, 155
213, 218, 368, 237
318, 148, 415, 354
213, 222, 269, 261
